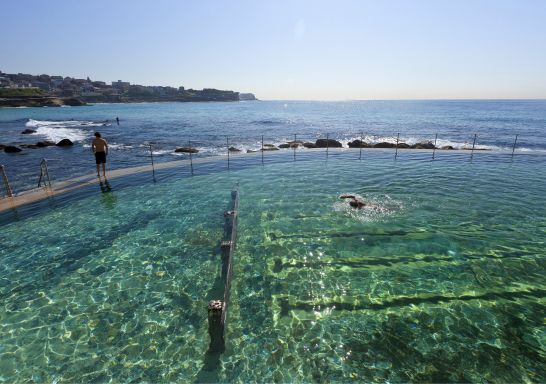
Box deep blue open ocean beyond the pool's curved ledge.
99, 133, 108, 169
0, 100, 546, 193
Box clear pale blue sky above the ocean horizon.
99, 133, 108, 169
0, 0, 546, 100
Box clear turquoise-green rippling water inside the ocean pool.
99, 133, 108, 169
0, 151, 546, 383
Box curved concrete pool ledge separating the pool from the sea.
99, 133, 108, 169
0, 148, 544, 213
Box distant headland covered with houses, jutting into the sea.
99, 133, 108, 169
0, 71, 257, 107
